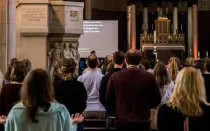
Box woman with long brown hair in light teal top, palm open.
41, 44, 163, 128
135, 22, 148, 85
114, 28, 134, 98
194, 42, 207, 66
5, 69, 84, 131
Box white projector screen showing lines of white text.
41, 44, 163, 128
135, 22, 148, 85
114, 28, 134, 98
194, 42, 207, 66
79, 20, 118, 58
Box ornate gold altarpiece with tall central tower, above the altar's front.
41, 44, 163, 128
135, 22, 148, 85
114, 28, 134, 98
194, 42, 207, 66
140, 16, 185, 51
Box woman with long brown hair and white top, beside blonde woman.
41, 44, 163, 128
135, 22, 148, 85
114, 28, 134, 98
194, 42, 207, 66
153, 62, 174, 102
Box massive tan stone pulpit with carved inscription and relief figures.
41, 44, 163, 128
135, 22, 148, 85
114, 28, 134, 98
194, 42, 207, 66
17, 0, 84, 75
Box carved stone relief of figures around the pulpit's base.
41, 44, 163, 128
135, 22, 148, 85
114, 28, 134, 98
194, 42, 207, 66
48, 42, 80, 76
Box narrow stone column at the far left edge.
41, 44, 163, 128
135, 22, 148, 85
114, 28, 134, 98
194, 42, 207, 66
0, 0, 7, 73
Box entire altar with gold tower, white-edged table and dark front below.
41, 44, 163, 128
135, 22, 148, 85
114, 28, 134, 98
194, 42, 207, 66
140, 16, 185, 63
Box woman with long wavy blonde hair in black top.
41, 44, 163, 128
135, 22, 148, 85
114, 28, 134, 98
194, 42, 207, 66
157, 67, 210, 131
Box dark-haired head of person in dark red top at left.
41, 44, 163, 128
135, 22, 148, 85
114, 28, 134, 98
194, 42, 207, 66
10, 61, 28, 82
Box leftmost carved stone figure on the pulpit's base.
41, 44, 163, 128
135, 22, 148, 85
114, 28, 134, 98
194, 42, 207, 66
48, 42, 63, 76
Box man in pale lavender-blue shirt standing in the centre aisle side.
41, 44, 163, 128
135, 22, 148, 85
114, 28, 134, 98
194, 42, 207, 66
78, 55, 105, 118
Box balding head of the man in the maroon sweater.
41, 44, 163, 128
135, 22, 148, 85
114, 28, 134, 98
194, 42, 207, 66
125, 49, 141, 66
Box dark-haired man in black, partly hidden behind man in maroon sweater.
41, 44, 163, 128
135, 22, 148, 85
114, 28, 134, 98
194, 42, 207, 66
99, 51, 125, 116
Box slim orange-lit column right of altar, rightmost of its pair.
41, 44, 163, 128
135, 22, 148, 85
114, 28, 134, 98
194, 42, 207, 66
192, 4, 198, 59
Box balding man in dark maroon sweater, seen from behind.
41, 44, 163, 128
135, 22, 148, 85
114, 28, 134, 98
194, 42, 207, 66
106, 50, 161, 131
